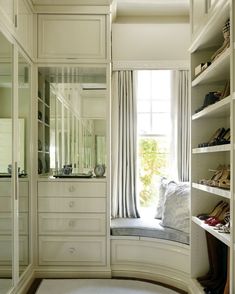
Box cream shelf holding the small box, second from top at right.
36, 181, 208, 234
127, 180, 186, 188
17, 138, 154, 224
192, 48, 231, 87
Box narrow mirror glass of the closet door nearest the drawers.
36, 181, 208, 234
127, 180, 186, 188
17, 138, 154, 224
18, 54, 30, 275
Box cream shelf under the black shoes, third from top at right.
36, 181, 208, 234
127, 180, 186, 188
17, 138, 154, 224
192, 95, 231, 120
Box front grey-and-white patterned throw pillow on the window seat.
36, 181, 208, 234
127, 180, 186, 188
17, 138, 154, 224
161, 182, 190, 233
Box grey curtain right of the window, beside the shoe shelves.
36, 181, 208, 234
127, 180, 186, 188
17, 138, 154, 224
172, 70, 190, 181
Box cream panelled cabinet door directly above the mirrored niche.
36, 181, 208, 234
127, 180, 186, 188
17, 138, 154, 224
38, 15, 106, 60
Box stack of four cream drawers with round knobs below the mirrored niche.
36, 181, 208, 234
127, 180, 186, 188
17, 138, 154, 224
38, 180, 107, 271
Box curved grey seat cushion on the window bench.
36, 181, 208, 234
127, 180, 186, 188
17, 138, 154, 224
111, 218, 189, 244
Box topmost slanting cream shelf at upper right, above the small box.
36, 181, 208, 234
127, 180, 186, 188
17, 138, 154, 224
189, 1, 230, 52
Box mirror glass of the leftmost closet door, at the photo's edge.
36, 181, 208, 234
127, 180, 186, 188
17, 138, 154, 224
0, 33, 13, 293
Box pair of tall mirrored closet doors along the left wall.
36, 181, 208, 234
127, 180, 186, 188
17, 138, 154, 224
0, 32, 31, 294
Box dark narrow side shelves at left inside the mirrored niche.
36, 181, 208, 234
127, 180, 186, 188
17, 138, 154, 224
38, 73, 50, 174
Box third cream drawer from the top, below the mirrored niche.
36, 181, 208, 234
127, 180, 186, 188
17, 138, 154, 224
38, 213, 106, 236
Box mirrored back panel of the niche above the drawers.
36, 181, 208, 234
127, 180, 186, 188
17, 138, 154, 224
38, 67, 106, 175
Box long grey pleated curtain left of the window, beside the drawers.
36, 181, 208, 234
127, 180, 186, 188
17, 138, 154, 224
111, 71, 139, 218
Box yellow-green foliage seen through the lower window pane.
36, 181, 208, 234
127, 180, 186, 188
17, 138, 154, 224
139, 138, 168, 207
